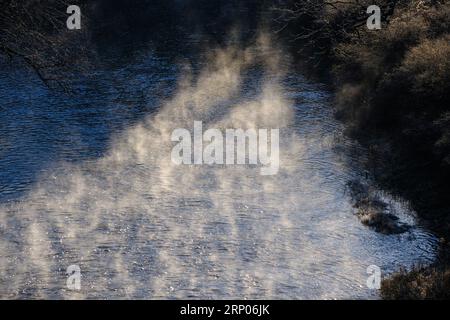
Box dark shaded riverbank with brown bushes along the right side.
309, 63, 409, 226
275, 1, 450, 299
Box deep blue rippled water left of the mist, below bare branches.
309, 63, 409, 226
0, 53, 178, 202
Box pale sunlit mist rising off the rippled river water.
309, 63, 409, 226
0, 37, 436, 299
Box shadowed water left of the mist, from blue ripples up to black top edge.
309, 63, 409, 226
0, 0, 270, 202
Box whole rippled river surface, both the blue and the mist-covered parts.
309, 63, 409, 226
0, 33, 437, 299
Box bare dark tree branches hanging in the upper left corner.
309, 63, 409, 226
0, 0, 89, 89
